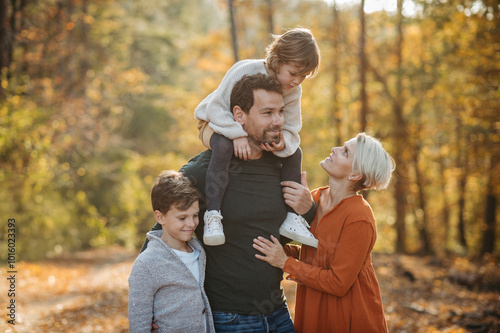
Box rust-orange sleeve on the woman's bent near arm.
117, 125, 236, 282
283, 221, 374, 297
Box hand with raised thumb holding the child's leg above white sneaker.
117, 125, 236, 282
281, 171, 313, 215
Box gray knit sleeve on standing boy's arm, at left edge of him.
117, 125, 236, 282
128, 258, 156, 333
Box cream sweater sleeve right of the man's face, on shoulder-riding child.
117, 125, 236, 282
274, 85, 302, 158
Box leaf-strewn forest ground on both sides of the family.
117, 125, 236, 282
0, 247, 500, 333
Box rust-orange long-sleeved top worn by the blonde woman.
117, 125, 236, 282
283, 187, 387, 333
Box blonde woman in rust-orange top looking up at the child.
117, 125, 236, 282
254, 133, 395, 333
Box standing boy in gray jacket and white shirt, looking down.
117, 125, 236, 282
128, 170, 215, 333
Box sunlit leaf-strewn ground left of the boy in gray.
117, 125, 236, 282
0, 247, 136, 333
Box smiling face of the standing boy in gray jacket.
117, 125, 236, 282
155, 201, 200, 251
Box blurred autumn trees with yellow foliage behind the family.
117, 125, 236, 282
0, 0, 500, 259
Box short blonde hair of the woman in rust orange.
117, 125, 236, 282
352, 133, 396, 192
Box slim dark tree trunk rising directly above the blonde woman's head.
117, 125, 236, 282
359, 0, 368, 132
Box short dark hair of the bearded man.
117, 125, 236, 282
230, 73, 282, 113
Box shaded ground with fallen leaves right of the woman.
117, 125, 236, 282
373, 254, 500, 333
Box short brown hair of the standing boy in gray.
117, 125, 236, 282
151, 170, 200, 214
